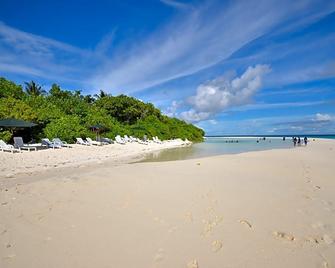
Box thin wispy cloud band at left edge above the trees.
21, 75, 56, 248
0, 22, 95, 83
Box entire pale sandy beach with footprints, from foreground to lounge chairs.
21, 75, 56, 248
0, 139, 335, 268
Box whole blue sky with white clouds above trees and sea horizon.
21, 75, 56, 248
0, 0, 335, 135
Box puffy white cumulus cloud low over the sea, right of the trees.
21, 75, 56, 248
180, 64, 270, 122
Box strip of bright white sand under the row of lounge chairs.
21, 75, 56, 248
0, 139, 190, 178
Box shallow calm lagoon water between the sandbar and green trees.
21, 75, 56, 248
141, 137, 293, 162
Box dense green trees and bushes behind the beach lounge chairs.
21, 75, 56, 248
0, 78, 205, 142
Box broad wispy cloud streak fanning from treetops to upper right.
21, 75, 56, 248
92, 1, 335, 93
